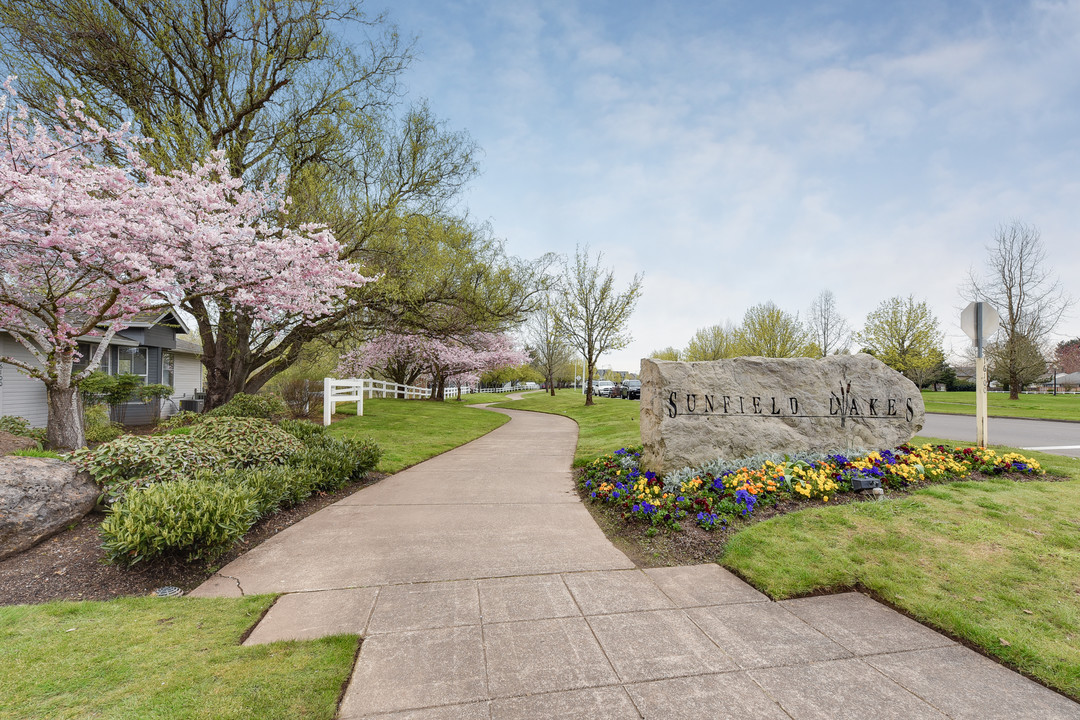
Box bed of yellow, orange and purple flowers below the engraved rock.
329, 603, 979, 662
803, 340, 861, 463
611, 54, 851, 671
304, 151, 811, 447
578, 445, 1043, 530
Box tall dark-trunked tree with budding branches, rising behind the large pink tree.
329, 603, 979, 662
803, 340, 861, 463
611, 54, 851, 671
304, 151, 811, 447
0, 0, 476, 408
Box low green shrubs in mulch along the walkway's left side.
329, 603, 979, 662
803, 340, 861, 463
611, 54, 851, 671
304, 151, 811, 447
91, 418, 381, 565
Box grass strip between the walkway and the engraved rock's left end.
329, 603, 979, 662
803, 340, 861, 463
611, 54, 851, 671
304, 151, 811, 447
498, 390, 642, 466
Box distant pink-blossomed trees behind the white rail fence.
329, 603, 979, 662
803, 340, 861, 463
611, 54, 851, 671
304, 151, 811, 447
337, 332, 529, 400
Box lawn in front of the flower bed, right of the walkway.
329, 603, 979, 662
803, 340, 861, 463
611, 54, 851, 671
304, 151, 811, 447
720, 452, 1080, 699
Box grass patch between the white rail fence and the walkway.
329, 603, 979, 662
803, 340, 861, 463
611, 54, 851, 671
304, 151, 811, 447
329, 398, 509, 473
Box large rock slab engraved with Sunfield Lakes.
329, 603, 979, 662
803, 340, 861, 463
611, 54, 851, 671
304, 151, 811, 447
642, 354, 924, 473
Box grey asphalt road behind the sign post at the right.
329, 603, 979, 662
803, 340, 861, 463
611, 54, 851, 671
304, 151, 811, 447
919, 412, 1080, 458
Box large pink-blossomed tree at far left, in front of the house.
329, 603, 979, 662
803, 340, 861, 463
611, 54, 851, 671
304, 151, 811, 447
0, 78, 367, 448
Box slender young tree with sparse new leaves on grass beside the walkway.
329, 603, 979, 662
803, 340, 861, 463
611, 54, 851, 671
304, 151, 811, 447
554, 245, 642, 406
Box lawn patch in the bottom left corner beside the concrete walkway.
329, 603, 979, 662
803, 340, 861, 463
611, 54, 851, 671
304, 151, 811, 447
0, 595, 359, 720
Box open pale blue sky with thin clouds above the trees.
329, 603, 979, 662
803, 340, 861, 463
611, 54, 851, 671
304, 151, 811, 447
365, 0, 1080, 370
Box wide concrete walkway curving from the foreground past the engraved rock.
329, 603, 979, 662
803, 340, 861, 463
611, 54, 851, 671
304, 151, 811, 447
192, 411, 1080, 720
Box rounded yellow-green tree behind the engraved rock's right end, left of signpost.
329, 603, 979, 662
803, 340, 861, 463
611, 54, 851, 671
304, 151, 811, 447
855, 296, 945, 388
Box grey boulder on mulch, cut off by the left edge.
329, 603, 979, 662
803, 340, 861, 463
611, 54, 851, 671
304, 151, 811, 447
0, 458, 100, 559
